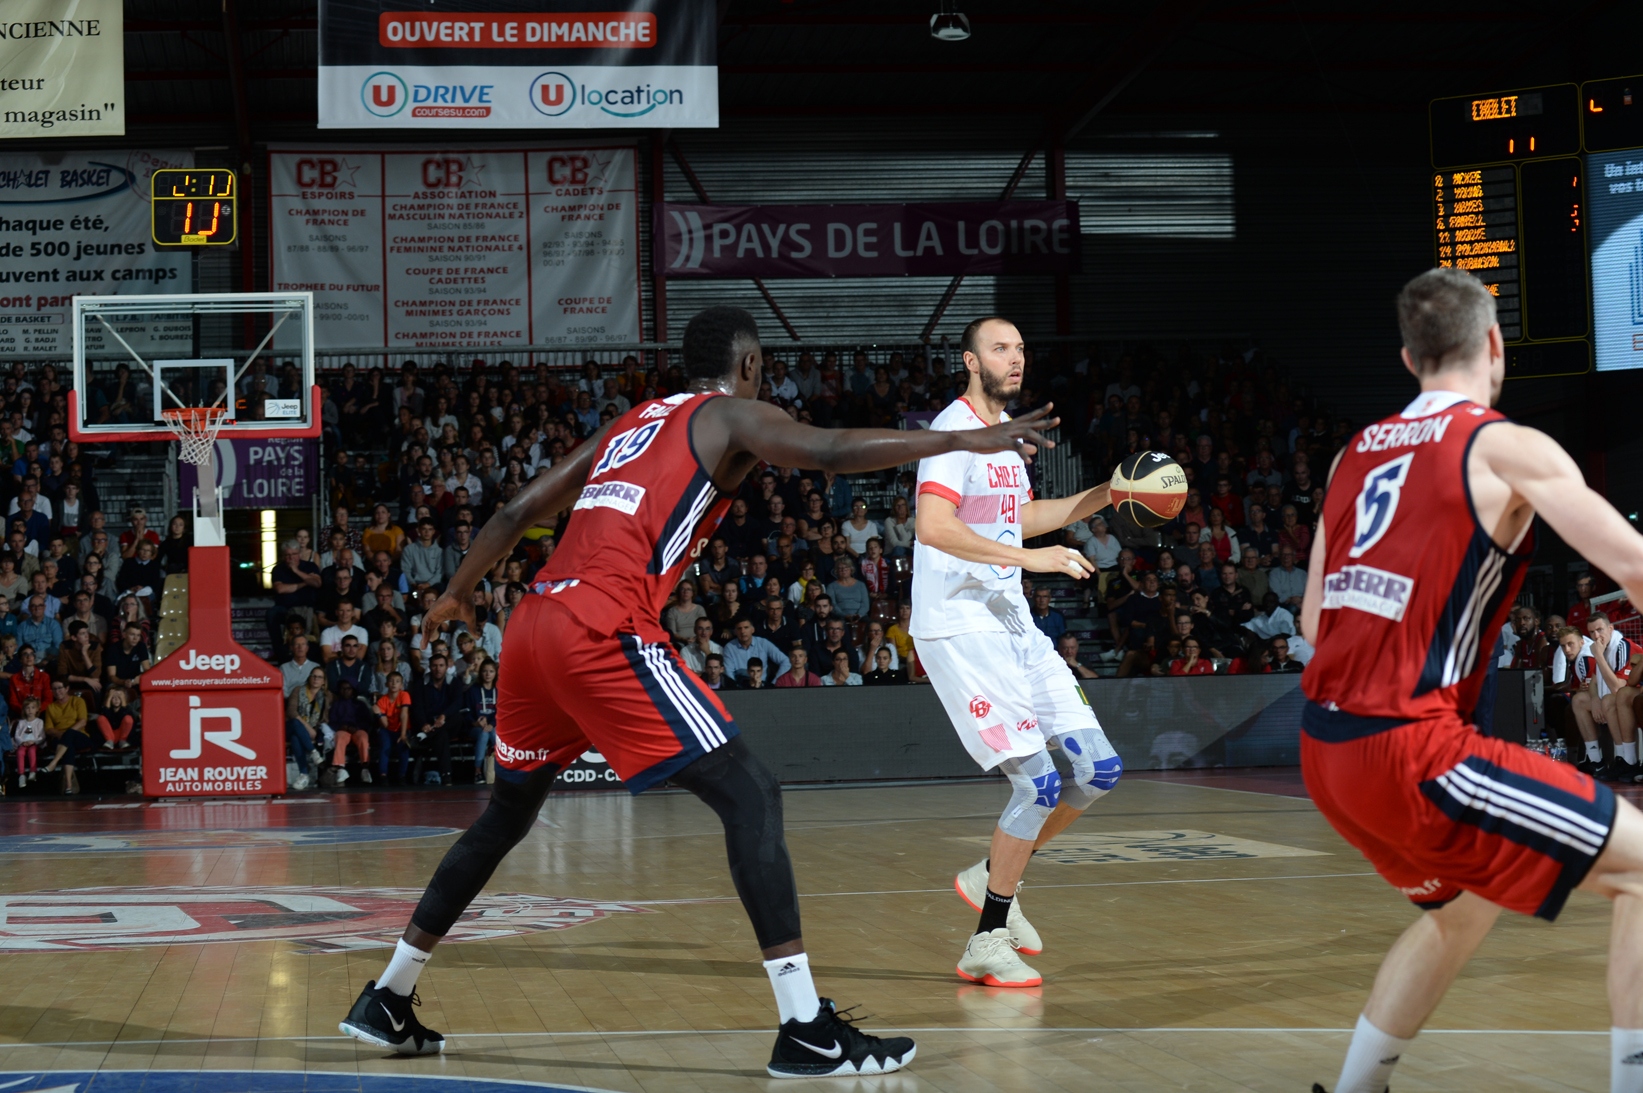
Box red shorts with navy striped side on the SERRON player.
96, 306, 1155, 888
1301, 702, 1615, 920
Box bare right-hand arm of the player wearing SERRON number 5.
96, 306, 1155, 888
1472, 422, 1643, 603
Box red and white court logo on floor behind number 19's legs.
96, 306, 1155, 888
0, 886, 646, 953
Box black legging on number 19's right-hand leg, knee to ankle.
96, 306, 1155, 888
672, 736, 800, 948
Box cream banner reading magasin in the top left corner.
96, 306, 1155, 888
0, 0, 125, 138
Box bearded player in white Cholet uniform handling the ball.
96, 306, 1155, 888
910, 316, 1122, 986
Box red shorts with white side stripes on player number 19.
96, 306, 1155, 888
496, 595, 736, 794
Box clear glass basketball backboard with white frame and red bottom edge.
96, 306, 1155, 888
69, 293, 322, 444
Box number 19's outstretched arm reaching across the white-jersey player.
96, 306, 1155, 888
706, 398, 1061, 475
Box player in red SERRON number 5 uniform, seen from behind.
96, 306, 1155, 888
1301, 270, 1643, 1093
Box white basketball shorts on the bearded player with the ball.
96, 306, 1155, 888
918, 626, 1104, 771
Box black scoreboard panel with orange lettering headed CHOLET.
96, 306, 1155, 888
1428, 84, 1592, 378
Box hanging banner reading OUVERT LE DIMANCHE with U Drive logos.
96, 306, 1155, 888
319, 0, 718, 128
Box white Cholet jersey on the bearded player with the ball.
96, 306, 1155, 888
910, 398, 1033, 641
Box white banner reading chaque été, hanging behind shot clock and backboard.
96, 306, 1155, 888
0, 150, 194, 357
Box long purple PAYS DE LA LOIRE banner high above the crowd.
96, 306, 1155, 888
656, 201, 1079, 278
